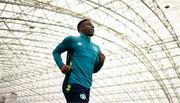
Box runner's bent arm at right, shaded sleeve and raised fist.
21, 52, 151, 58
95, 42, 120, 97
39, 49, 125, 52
93, 52, 105, 73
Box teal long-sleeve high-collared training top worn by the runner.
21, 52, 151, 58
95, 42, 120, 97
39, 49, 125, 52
53, 34, 103, 88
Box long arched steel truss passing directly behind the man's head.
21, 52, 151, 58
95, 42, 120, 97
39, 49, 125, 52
0, 0, 172, 101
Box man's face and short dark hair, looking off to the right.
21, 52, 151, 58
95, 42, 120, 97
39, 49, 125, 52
80, 20, 94, 36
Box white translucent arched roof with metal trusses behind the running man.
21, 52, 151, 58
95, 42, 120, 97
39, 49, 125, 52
0, 0, 180, 103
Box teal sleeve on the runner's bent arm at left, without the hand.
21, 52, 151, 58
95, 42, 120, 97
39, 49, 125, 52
52, 36, 72, 68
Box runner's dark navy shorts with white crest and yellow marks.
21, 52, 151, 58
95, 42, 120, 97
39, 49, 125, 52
63, 74, 90, 103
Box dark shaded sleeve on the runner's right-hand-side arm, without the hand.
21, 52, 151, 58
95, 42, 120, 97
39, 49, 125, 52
93, 55, 104, 73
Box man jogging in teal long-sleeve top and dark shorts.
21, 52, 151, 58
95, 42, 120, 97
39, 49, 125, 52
53, 19, 105, 103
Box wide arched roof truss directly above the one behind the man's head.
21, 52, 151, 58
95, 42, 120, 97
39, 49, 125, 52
80, 0, 180, 81
